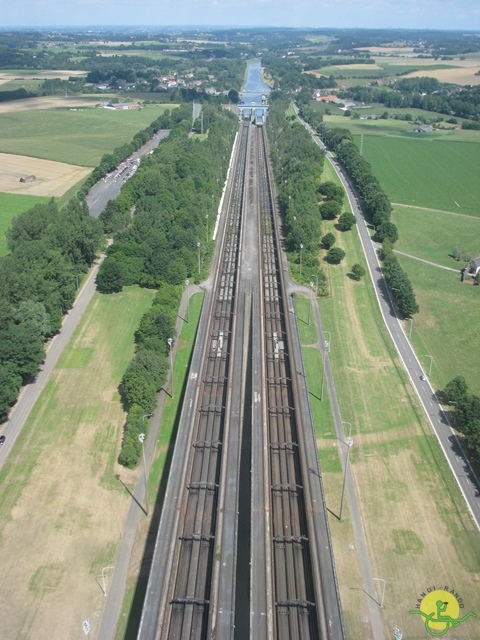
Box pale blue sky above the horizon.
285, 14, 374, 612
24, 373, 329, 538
0, 0, 480, 31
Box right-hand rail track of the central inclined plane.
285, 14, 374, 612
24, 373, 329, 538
255, 128, 345, 640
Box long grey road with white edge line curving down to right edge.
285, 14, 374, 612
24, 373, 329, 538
298, 110, 480, 529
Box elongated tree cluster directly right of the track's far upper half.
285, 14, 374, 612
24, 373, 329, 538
267, 92, 325, 292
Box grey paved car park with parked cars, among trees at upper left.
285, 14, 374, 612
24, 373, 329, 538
86, 129, 170, 218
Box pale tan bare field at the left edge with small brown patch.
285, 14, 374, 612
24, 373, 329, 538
0, 153, 91, 198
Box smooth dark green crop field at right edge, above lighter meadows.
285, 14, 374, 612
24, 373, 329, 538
363, 134, 480, 216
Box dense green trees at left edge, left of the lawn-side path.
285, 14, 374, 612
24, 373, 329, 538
0, 200, 103, 420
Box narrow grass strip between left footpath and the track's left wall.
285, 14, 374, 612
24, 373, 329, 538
115, 294, 204, 640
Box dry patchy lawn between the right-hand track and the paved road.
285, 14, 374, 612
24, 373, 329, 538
299, 192, 480, 640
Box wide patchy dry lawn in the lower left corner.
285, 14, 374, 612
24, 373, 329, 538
0, 287, 154, 640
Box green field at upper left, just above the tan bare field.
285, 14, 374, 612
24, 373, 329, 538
0, 104, 172, 167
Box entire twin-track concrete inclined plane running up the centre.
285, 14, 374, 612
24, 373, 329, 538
138, 123, 344, 640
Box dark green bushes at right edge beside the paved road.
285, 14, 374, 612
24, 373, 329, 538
439, 376, 480, 462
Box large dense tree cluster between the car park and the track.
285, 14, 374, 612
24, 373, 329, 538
97, 105, 238, 293
